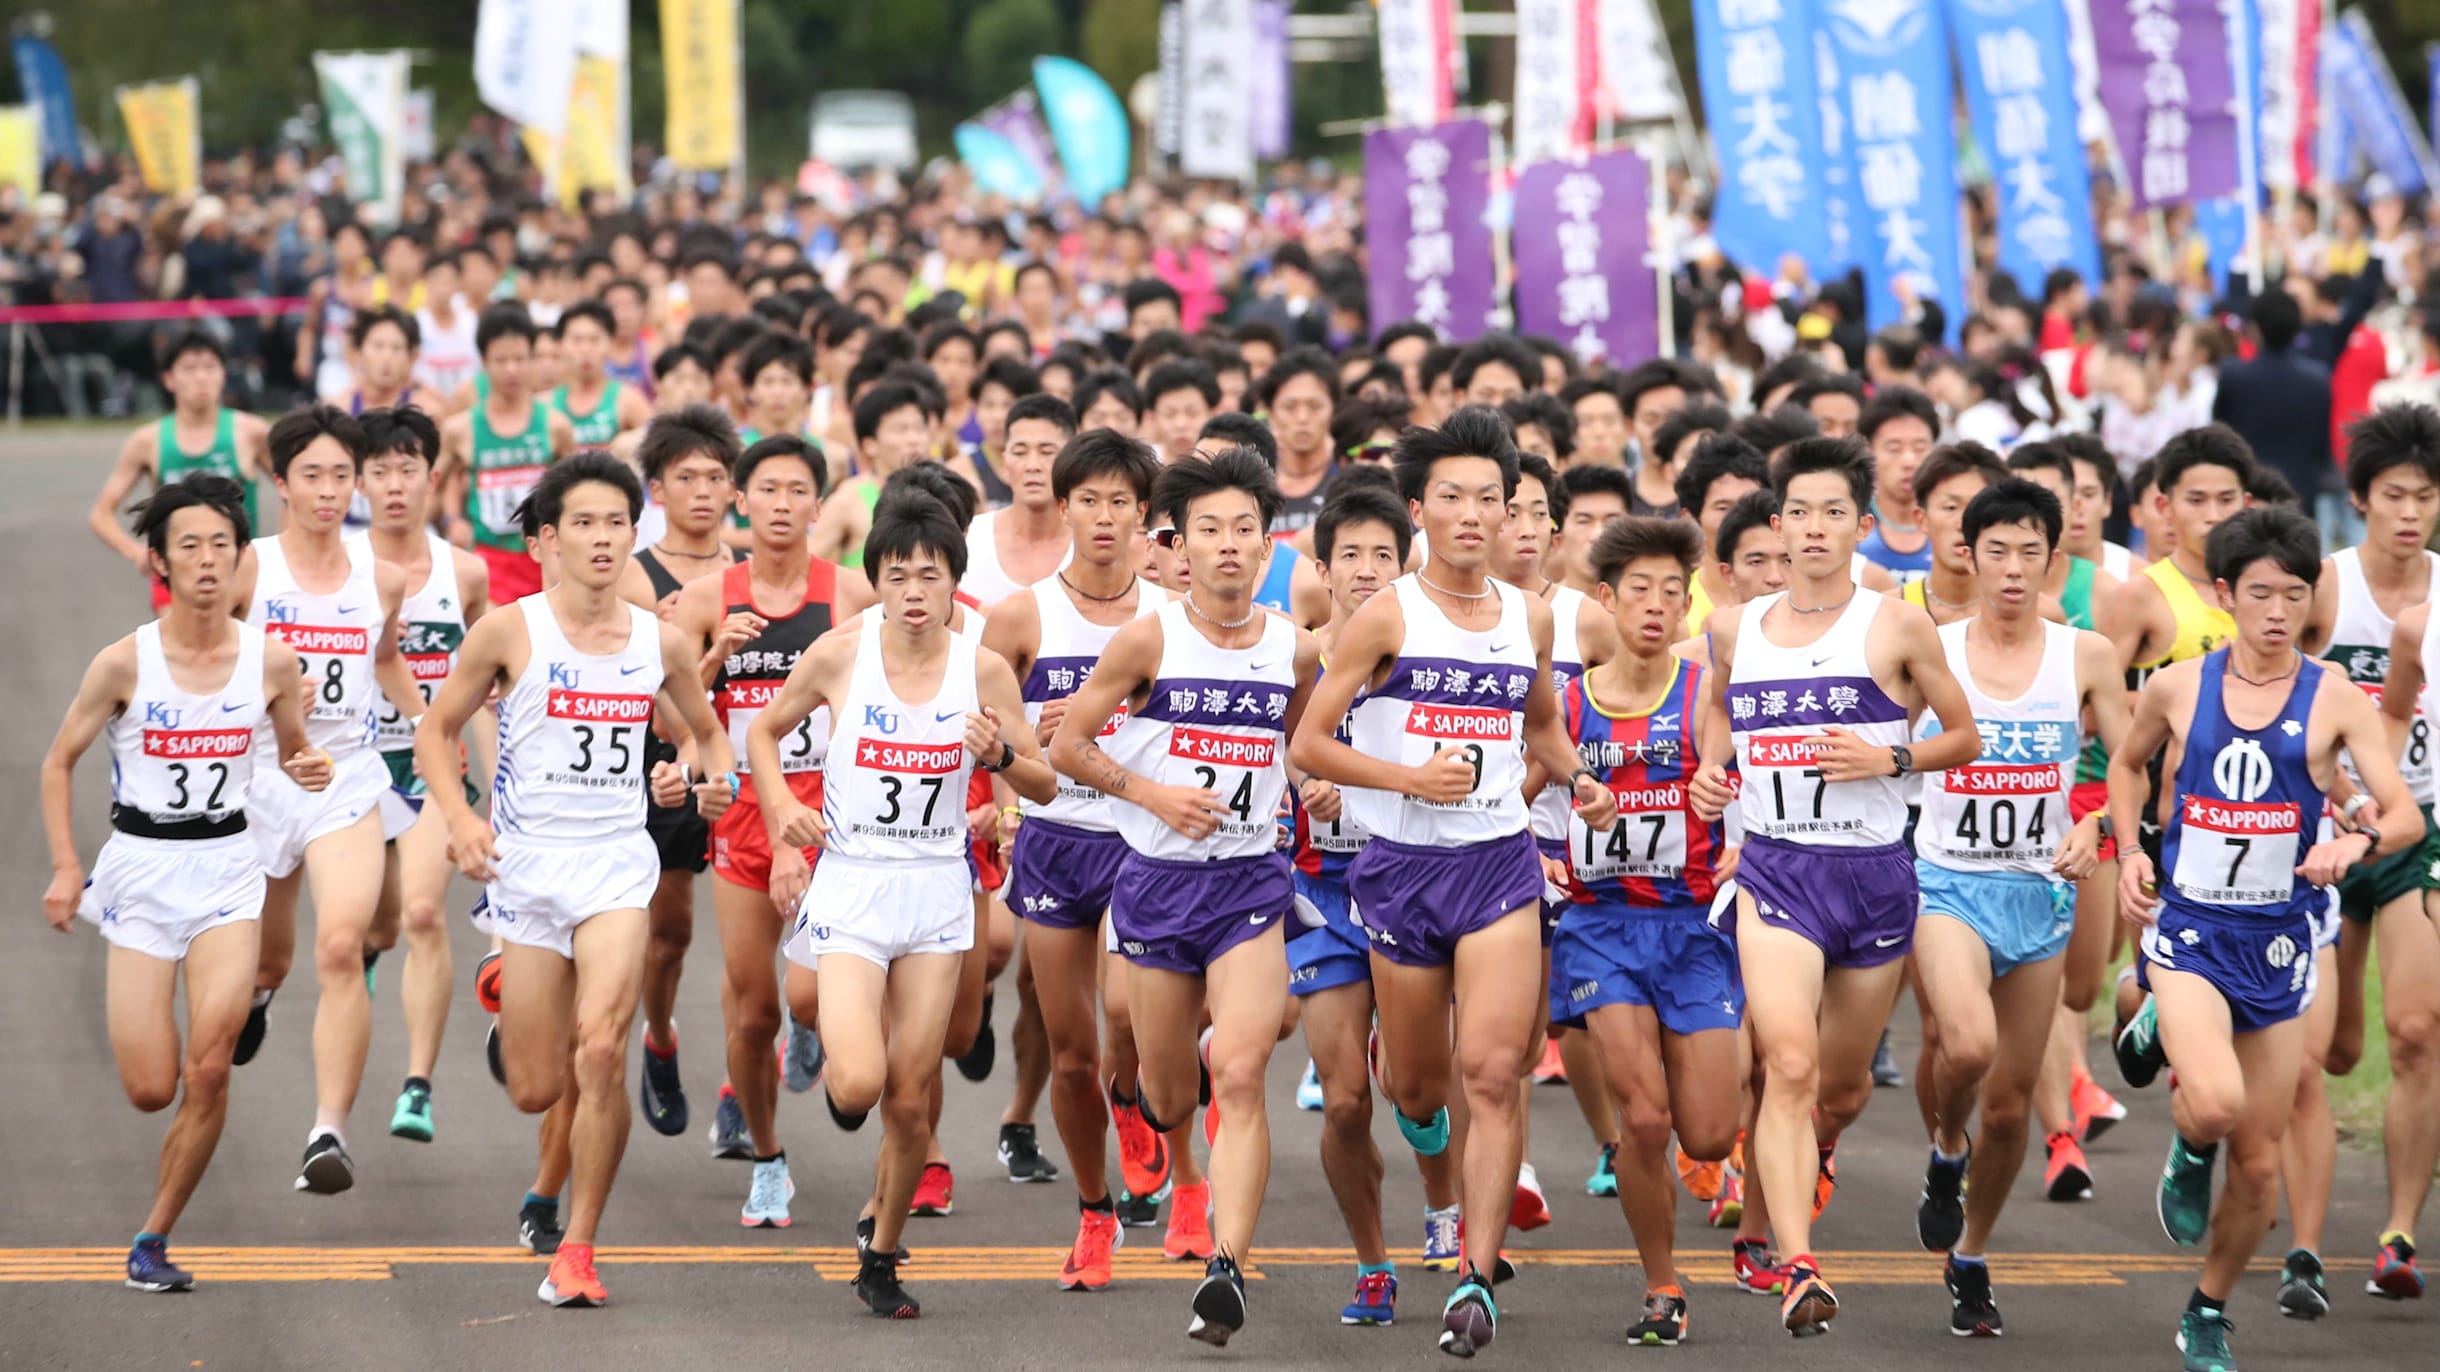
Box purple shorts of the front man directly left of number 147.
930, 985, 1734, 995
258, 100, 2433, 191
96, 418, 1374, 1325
1347, 830, 1549, 967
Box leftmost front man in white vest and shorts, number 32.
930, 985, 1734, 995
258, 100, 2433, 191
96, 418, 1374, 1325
41, 474, 329, 1291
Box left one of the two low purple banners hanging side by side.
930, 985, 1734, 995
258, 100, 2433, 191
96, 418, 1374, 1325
1364, 120, 1496, 342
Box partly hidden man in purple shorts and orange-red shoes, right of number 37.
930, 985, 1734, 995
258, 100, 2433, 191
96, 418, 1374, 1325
983, 422, 1169, 1291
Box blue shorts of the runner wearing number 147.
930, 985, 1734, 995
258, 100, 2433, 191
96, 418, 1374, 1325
1549, 901, 1745, 1035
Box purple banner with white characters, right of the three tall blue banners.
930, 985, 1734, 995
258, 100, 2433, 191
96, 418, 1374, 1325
2091, 0, 2242, 210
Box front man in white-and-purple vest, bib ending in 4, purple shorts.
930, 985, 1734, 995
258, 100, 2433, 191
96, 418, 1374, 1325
1052, 447, 1317, 1348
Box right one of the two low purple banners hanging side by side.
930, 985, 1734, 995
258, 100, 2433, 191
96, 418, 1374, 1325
1508, 151, 1662, 369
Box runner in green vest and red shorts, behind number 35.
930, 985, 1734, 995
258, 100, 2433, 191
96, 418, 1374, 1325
442, 303, 576, 605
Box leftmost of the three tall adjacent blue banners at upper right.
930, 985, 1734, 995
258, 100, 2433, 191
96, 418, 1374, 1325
1693, 0, 1830, 278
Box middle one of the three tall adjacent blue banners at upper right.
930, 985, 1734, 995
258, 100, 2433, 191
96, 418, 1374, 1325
1823, 0, 1961, 339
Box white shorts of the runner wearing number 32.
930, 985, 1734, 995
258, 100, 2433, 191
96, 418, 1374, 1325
76, 832, 264, 962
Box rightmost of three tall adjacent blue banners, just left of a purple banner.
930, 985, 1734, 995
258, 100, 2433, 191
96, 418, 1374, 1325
1947, 0, 2101, 300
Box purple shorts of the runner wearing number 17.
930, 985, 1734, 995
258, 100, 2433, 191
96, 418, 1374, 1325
1737, 835, 1923, 967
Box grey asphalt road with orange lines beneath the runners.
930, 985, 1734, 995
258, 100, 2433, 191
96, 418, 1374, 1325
0, 432, 2440, 1372
